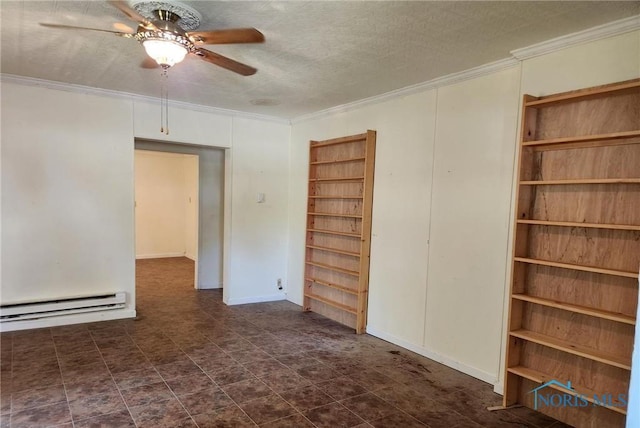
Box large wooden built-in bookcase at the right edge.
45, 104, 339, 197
504, 79, 640, 428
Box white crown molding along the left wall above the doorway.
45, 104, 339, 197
0, 73, 291, 125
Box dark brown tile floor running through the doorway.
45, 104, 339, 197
0, 258, 563, 428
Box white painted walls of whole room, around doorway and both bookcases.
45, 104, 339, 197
0, 25, 640, 397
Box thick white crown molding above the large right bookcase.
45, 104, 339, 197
510, 15, 640, 61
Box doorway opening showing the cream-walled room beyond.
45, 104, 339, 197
134, 139, 225, 298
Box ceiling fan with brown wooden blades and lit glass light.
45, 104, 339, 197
40, 0, 264, 76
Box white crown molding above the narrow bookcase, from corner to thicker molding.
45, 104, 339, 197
291, 58, 519, 124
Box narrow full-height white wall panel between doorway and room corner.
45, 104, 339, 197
225, 118, 289, 304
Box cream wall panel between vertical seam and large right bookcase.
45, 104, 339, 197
425, 67, 520, 381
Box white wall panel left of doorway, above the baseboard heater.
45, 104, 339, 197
0, 84, 135, 322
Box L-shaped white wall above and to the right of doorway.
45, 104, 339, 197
134, 100, 290, 304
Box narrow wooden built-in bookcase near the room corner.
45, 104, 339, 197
304, 131, 376, 333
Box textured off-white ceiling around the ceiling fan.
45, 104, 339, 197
0, 0, 640, 118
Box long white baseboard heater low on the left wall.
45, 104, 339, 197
0, 292, 126, 323
